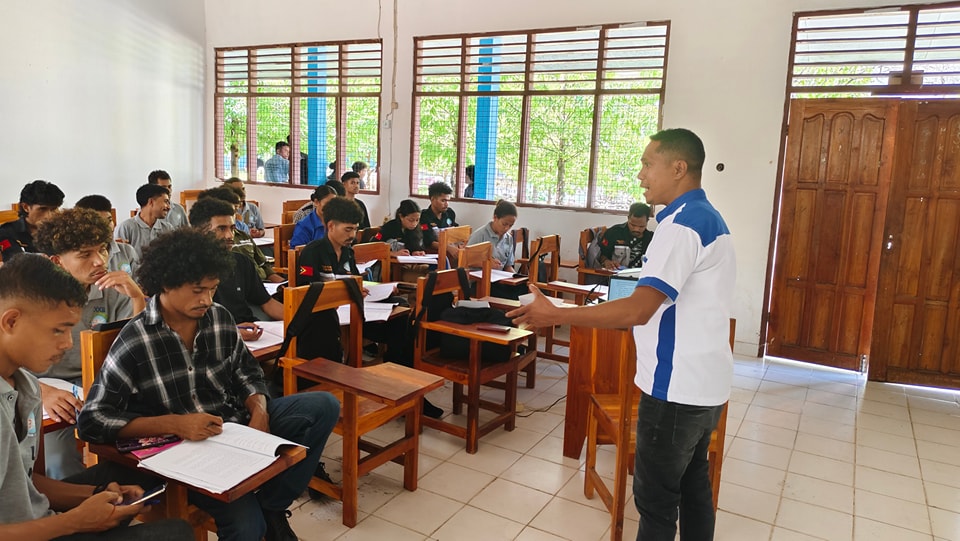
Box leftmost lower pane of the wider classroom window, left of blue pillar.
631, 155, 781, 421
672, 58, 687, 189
413, 96, 460, 195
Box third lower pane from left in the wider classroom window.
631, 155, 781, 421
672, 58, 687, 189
523, 96, 594, 207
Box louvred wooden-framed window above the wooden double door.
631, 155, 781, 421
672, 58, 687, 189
787, 2, 960, 98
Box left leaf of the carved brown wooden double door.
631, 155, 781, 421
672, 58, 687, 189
767, 99, 898, 370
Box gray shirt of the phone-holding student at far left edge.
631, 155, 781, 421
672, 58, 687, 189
0, 368, 53, 524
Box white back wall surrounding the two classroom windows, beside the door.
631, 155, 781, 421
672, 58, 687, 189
204, 0, 936, 354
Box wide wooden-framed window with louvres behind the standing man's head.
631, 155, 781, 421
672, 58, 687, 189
410, 22, 670, 211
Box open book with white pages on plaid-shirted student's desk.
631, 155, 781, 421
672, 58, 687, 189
140, 423, 297, 494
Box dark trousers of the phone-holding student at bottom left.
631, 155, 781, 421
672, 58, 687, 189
56, 464, 193, 541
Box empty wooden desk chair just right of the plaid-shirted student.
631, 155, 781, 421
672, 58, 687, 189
280, 277, 443, 528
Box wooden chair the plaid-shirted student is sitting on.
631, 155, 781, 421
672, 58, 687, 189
80, 320, 217, 541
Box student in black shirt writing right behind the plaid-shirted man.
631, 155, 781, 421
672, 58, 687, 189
190, 197, 283, 334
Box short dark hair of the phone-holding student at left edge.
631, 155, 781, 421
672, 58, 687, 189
0, 253, 87, 307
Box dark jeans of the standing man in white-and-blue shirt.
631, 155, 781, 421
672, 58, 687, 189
633, 393, 723, 541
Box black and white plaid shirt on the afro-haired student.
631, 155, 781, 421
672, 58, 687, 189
77, 296, 267, 443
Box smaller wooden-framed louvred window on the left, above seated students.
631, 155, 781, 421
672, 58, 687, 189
214, 39, 382, 192
